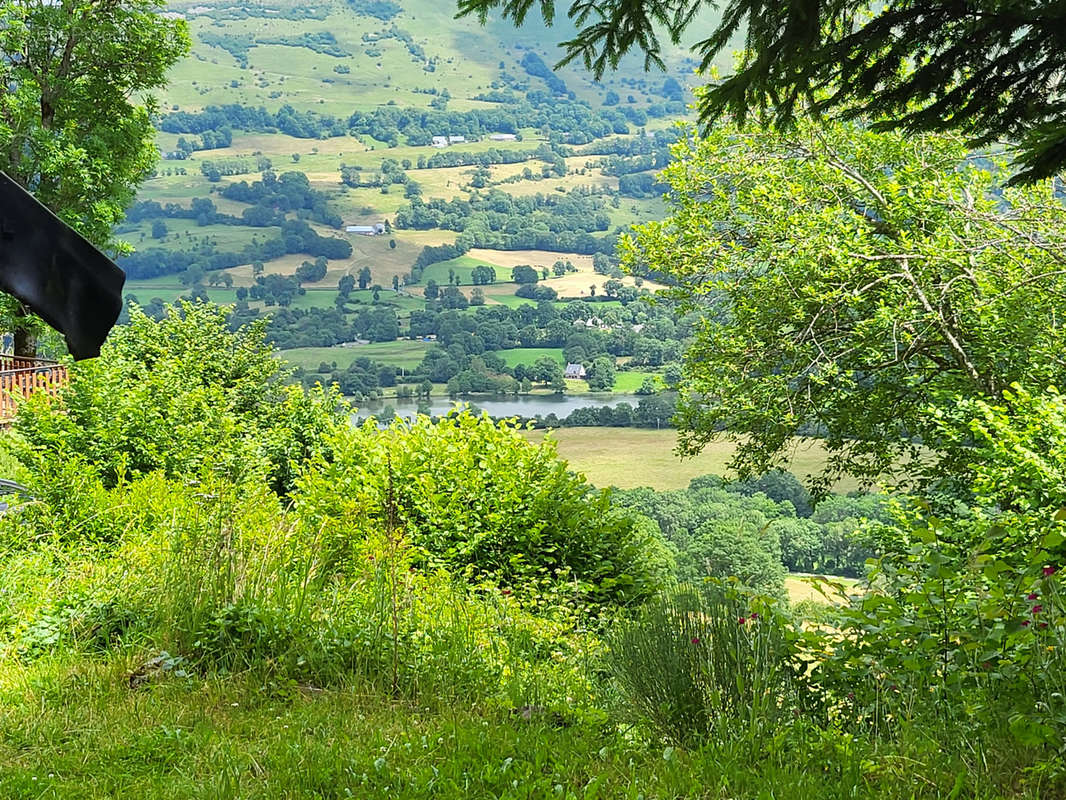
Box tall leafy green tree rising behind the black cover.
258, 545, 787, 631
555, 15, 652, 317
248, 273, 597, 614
0, 0, 189, 356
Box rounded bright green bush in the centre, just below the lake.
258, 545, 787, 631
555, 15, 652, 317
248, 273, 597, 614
294, 412, 667, 605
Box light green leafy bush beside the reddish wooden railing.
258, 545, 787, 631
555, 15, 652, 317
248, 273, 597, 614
7, 303, 344, 495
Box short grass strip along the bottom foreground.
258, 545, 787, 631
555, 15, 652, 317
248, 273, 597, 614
0, 653, 916, 800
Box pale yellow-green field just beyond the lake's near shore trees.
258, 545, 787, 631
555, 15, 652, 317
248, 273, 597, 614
526, 428, 858, 492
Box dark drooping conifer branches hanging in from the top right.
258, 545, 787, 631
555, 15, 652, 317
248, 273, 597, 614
458, 0, 1066, 181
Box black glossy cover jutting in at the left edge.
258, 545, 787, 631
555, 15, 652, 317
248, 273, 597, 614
0, 172, 126, 359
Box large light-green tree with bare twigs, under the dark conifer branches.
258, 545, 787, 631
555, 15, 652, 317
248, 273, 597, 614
624, 117, 1066, 490
